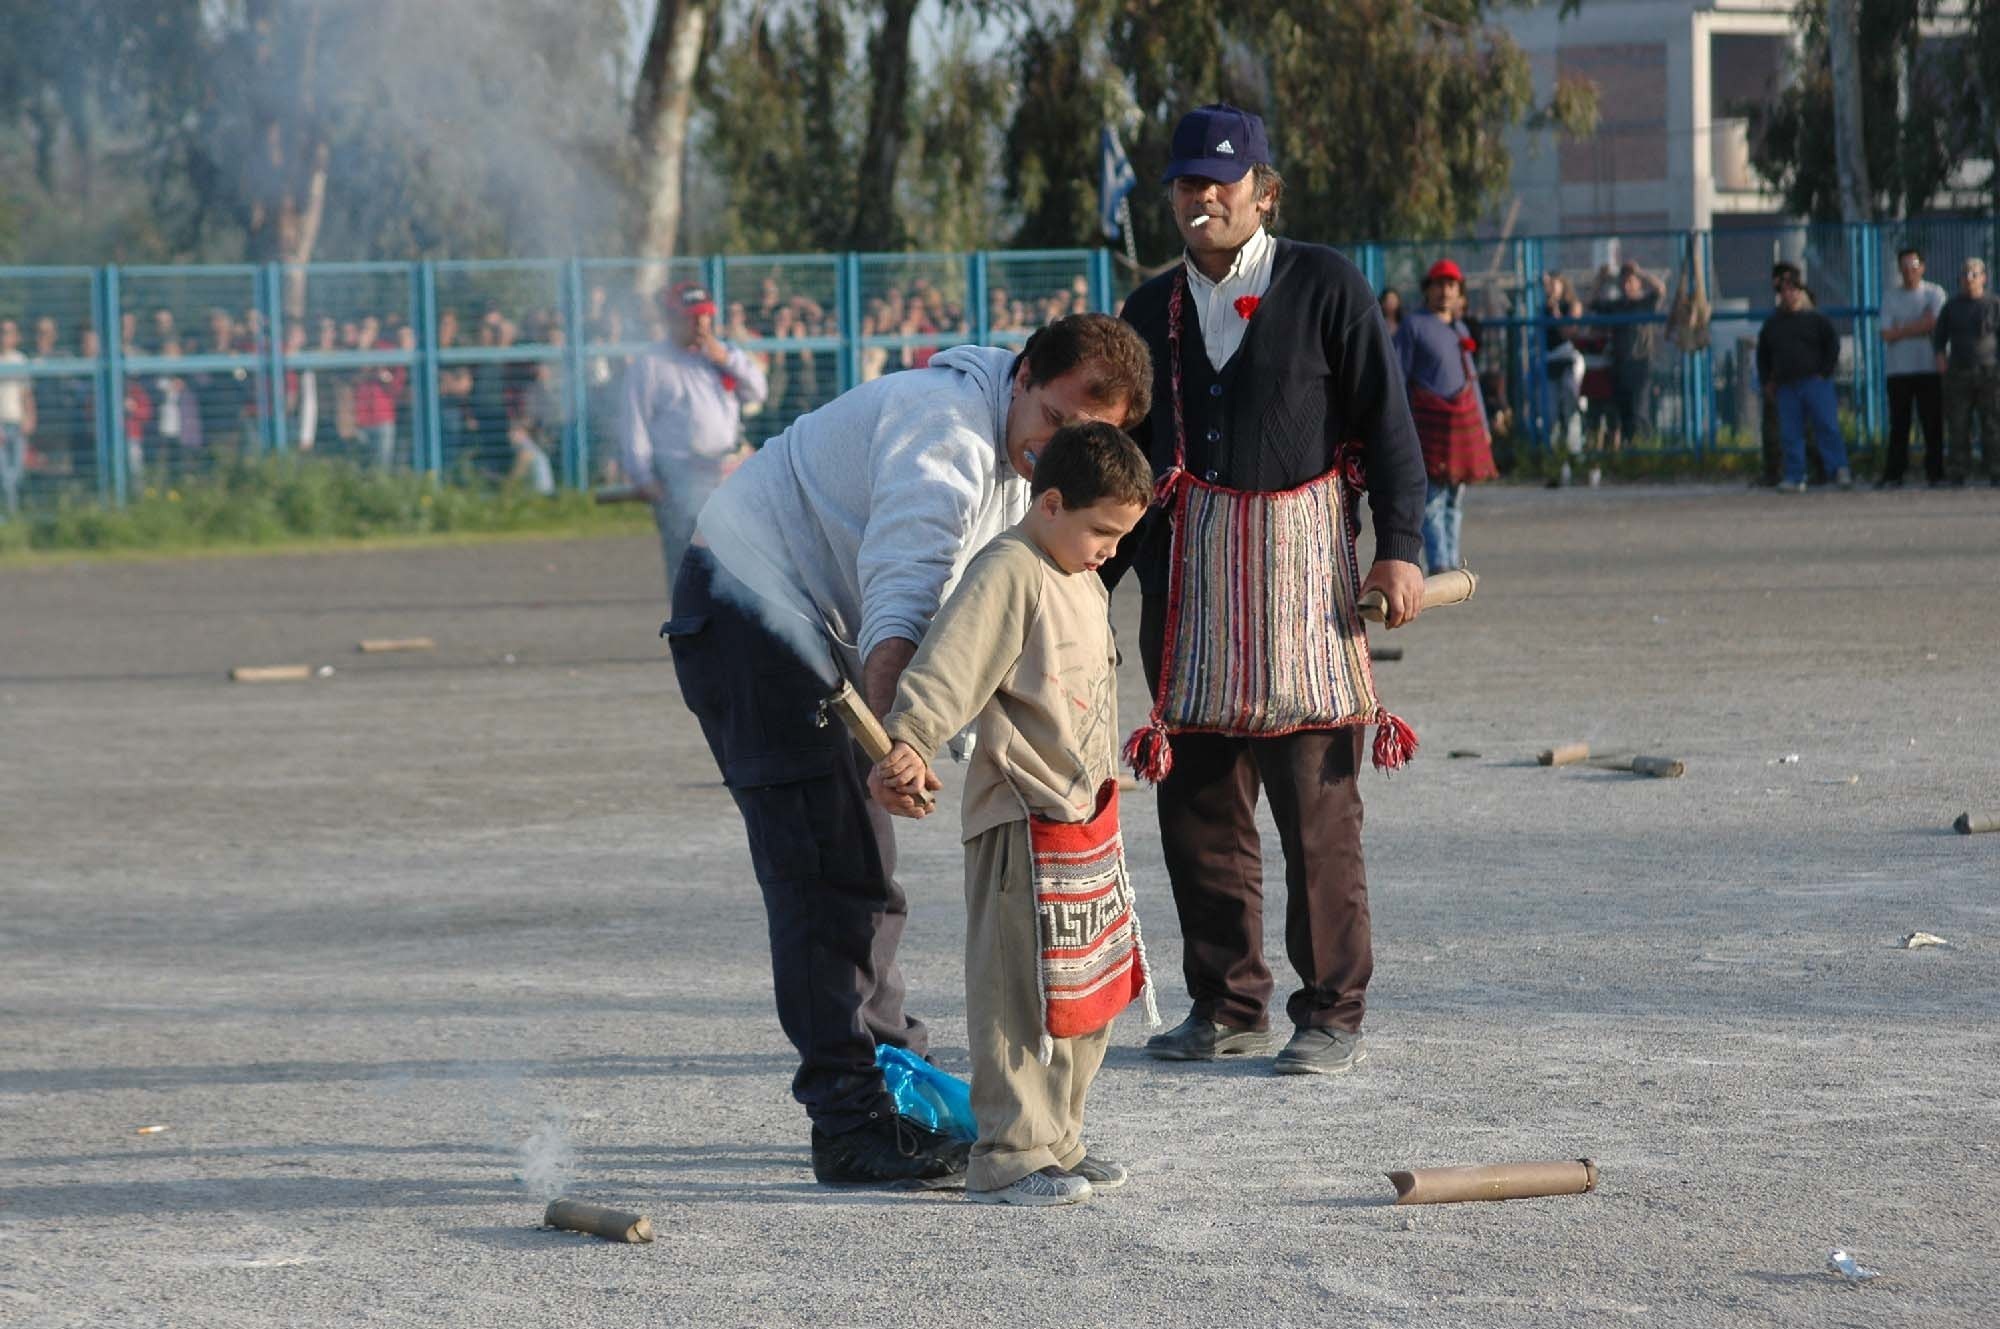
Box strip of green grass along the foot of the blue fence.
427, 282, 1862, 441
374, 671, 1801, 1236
0, 456, 652, 560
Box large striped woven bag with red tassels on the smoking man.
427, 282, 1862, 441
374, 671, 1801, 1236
1124, 270, 1416, 783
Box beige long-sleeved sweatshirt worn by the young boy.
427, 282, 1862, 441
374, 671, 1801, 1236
884, 526, 1118, 841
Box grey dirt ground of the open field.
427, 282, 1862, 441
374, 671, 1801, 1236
0, 488, 2000, 1329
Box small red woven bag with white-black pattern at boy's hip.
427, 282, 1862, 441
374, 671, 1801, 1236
1028, 781, 1160, 1065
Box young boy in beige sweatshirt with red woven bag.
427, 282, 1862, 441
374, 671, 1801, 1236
870, 424, 1152, 1205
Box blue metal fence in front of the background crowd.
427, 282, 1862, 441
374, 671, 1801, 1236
0, 228, 2000, 502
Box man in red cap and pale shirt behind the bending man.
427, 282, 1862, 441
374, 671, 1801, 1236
618, 282, 766, 598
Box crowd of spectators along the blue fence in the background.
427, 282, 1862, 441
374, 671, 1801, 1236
0, 248, 2000, 512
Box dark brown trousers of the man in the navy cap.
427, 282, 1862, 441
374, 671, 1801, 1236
1140, 596, 1374, 1033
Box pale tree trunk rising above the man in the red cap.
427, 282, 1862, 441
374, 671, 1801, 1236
632, 0, 714, 290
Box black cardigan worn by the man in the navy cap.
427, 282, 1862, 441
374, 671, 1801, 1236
1106, 238, 1426, 594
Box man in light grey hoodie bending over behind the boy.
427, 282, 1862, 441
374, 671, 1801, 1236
662, 314, 1152, 1187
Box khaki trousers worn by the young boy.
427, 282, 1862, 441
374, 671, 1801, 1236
966, 821, 1112, 1191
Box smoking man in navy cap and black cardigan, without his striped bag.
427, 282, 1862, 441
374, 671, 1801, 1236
1106, 104, 1424, 1075
